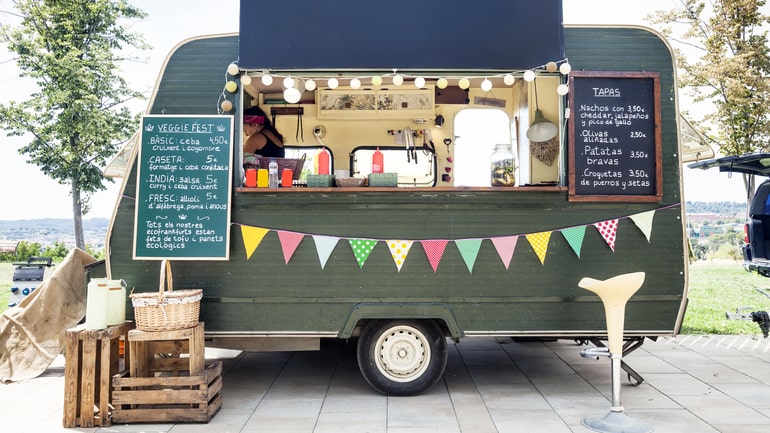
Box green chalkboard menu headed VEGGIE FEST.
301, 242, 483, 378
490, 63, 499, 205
134, 116, 233, 260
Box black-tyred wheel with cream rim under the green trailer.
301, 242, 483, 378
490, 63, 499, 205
357, 320, 447, 395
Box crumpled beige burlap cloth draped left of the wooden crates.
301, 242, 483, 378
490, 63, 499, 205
0, 248, 96, 382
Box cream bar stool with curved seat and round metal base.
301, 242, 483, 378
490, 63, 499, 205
578, 272, 653, 433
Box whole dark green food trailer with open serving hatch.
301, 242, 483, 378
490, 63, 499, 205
105, 0, 697, 395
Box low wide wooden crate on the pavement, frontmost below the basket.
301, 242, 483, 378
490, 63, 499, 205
112, 362, 222, 423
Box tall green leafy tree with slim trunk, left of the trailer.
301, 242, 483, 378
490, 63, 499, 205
0, 0, 146, 248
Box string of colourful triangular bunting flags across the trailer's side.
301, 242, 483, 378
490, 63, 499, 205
233, 204, 679, 274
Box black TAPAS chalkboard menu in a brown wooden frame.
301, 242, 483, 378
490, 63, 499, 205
569, 71, 662, 202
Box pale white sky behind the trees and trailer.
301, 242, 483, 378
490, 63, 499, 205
0, 0, 745, 220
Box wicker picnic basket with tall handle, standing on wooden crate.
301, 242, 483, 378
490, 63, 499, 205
130, 260, 203, 331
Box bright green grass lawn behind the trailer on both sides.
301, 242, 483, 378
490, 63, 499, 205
0, 261, 770, 334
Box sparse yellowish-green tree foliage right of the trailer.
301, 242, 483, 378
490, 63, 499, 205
652, 0, 770, 155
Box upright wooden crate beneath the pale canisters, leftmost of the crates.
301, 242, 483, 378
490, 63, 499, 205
62, 322, 134, 428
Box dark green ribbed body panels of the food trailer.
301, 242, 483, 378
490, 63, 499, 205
106, 27, 687, 392
